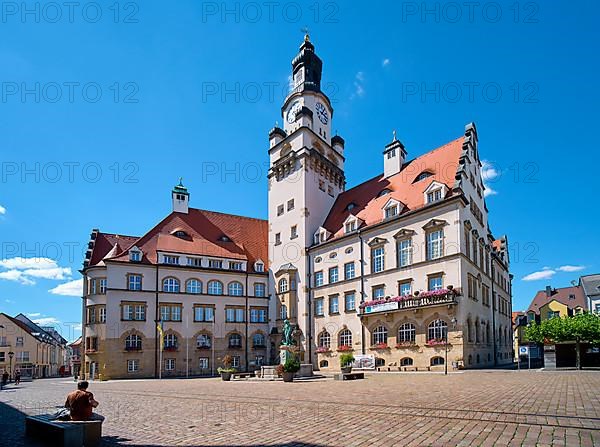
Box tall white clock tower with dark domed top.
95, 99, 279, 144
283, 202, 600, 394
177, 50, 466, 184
268, 35, 346, 363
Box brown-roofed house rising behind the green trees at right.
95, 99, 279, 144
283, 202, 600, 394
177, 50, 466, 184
527, 286, 588, 323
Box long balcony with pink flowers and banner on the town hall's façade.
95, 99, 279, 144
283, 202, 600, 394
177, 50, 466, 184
360, 289, 460, 317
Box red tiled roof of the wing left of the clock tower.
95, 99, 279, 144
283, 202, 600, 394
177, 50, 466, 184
109, 208, 268, 269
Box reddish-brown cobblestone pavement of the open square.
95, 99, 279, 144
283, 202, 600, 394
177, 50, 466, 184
0, 371, 600, 447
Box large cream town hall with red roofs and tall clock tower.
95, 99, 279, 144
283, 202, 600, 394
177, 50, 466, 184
82, 36, 513, 377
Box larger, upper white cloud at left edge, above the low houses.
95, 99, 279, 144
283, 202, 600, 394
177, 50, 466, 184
0, 257, 72, 285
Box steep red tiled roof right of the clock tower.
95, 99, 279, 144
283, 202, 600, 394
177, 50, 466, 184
323, 137, 464, 237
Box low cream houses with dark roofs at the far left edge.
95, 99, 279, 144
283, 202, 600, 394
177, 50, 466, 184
0, 313, 66, 378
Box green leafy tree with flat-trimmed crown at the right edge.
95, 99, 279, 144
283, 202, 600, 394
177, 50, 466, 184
525, 313, 600, 369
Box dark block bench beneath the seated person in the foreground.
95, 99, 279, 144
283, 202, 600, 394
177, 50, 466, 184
25, 414, 102, 447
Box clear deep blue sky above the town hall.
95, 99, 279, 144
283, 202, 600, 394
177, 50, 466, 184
0, 1, 600, 338
